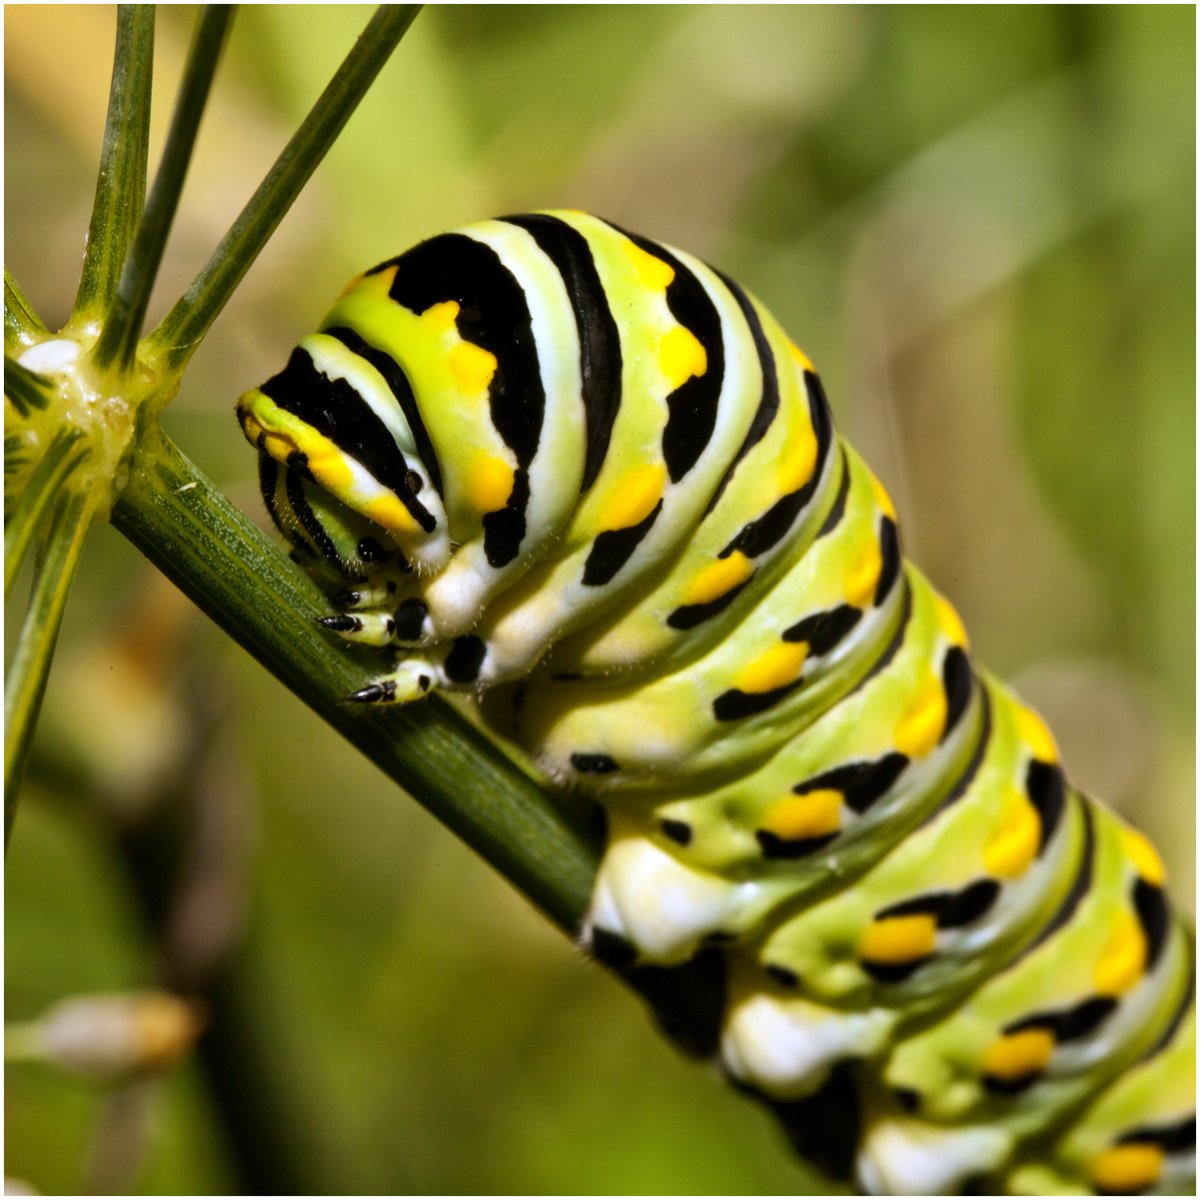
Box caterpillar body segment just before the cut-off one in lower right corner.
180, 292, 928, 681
862, 808, 1193, 1190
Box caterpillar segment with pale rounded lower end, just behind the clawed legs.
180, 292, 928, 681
497, 441, 907, 788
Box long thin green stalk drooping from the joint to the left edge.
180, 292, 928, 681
4, 482, 95, 848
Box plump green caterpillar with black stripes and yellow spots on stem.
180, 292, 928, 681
238, 211, 1195, 1195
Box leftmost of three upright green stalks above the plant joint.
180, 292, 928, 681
67, 5, 154, 327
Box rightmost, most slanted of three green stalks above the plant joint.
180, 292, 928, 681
144, 5, 420, 372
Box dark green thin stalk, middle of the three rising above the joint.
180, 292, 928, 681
94, 5, 234, 370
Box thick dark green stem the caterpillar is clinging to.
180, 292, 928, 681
113, 430, 599, 932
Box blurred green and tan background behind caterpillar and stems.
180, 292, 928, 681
5, 6, 1195, 1194
